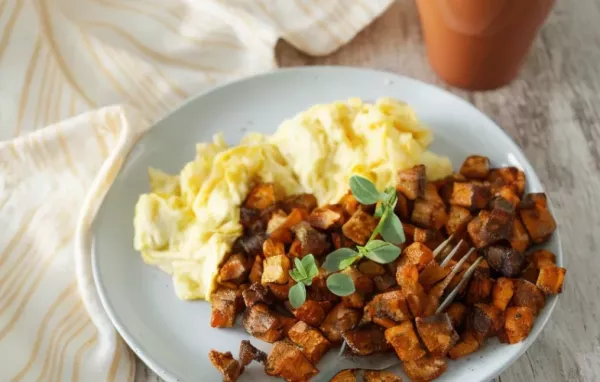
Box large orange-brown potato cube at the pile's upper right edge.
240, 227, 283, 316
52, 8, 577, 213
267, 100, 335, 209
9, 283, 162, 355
519, 193, 556, 244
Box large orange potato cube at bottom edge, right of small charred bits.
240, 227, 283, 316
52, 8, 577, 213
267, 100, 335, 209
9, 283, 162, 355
265, 341, 319, 382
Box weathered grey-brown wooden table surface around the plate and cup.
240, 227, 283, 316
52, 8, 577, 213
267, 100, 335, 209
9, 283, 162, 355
136, 0, 600, 382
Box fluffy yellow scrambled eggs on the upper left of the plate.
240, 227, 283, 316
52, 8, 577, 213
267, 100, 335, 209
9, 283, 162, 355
134, 98, 452, 300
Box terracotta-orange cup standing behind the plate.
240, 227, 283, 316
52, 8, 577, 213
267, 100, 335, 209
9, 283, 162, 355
417, 0, 555, 90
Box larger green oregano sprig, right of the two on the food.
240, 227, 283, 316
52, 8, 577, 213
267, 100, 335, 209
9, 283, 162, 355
323, 175, 406, 296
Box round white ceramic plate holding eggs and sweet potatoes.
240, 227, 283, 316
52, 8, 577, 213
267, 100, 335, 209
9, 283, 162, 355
93, 67, 562, 382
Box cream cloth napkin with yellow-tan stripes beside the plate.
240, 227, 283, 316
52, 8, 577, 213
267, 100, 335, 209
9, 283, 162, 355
0, 0, 392, 381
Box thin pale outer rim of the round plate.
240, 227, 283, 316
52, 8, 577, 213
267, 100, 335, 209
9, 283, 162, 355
90, 65, 564, 382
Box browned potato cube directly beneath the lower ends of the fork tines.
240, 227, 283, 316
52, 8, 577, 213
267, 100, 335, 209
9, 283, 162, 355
415, 313, 459, 357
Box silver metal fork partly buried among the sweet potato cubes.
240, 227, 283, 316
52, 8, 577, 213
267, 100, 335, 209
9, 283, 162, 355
311, 235, 483, 382
